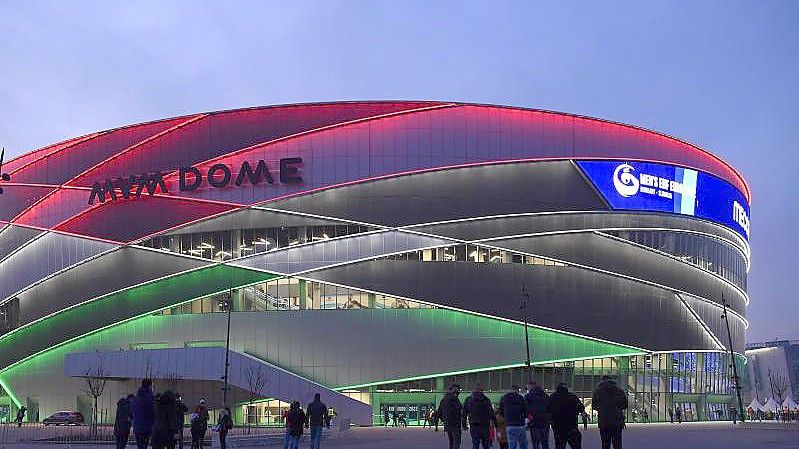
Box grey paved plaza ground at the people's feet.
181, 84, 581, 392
0, 422, 799, 449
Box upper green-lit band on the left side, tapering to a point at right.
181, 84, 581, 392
0, 265, 273, 369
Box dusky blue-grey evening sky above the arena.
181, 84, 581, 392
0, 0, 799, 341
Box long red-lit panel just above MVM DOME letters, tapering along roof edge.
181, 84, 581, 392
72, 102, 444, 186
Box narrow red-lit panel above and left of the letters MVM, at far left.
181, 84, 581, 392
13, 118, 185, 185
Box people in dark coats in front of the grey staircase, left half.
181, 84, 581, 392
114, 379, 334, 449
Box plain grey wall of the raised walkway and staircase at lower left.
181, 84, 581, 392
64, 348, 372, 426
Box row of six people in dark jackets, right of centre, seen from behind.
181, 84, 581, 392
433, 376, 627, 449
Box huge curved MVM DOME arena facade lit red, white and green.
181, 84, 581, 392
0, 101, 750, 424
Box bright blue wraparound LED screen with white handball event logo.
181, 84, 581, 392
576, 161, 749, 240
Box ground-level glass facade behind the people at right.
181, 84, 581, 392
356, 352, 743, 425
